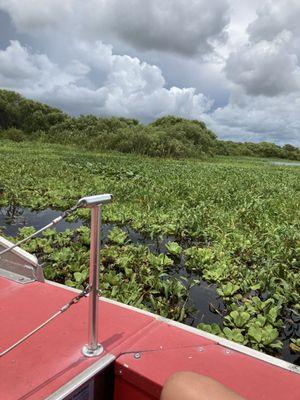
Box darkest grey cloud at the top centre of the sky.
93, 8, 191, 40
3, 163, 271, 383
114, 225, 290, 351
85, 0, 229, 56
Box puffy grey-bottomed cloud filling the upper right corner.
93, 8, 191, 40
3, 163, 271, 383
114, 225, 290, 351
224, 0, 300, 96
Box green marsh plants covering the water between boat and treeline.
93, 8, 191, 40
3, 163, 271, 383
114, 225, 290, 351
0, 142, 300, 360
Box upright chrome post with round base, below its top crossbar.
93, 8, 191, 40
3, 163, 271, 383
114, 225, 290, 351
82, 205, 103, 357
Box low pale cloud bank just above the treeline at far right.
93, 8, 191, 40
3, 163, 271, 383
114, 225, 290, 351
204, 91, 300, 146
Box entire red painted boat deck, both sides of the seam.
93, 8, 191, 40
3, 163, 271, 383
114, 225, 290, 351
0, 278, 300, 400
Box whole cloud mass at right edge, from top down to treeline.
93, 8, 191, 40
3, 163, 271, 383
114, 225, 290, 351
217, 0, 300, 146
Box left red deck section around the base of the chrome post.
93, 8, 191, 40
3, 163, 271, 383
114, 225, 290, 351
0, 278, 153, 400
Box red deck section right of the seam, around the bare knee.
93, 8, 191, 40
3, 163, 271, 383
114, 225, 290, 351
115, 323, 300, 400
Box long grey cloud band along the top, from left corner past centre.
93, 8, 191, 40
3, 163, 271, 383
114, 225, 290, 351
0, 0, 229, 56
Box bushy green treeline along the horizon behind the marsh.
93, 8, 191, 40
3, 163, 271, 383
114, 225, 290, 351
0, 90, 300, 160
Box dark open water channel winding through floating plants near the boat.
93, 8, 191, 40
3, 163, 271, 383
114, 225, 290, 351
0, 206, 300, 365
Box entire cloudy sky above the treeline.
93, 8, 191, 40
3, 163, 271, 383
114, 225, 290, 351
0, 0, 300, 146
